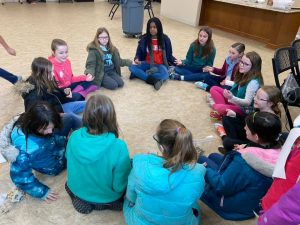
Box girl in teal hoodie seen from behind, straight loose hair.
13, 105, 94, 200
66, 95, 131, 214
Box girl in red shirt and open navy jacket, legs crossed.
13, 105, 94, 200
129, 17, 176, 90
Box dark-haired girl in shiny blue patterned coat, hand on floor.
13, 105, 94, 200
1, 102, 66, 202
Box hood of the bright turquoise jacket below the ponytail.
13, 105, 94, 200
133, 154, 195, 195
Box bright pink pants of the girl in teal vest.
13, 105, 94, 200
210, 86, 244, 116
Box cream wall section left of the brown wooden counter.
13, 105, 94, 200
160, 0, 202, 26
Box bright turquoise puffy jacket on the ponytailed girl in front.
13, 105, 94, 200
123, 154, 206, 225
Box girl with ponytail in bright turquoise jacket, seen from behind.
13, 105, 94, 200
123, 119, 205, 225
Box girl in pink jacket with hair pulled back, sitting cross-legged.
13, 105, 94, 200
48, 39, 97, 101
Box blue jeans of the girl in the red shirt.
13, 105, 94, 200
129, 61, 169, 81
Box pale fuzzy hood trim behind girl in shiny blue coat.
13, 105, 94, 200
0, 116, 19, 162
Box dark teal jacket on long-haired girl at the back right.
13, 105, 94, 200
183, 42, 216, 67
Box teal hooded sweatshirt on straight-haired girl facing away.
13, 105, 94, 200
66, 127, 131, 203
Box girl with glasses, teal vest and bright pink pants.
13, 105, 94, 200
210, 52, 264, 120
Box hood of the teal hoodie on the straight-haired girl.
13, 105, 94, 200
67, 127, 120, 164
